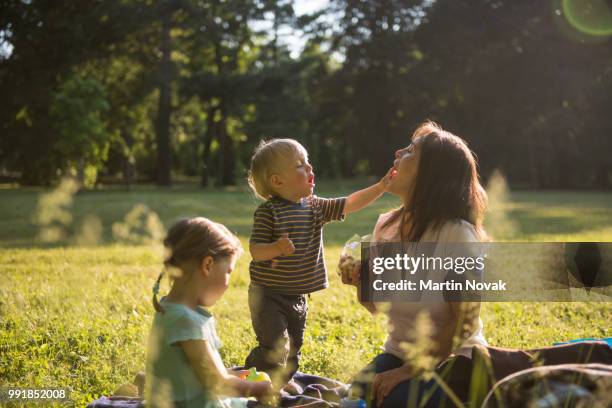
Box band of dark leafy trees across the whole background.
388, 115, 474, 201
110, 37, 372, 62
0, 0, 612, 188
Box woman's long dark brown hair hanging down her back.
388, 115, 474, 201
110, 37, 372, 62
381, 121, 487, 242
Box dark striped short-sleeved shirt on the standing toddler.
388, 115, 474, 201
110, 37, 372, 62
249, 195, 346, 295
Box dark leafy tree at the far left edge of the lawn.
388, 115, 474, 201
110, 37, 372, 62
0, 0, 148, 184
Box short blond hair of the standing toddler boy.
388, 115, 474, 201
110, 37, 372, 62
248, 139, 308, 200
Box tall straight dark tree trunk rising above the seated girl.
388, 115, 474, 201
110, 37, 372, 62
156, 12, 172, 186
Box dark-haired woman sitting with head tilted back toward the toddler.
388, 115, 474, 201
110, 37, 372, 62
345, 122, 487, 408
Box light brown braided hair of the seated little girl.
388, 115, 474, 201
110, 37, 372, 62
153, 217, 242, 313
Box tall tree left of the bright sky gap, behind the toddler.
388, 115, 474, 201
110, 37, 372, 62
181, 0, 292, 186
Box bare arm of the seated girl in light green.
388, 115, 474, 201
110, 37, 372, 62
179, 340, 272, 398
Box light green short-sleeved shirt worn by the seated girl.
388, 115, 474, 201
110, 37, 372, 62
145, 299, 246, 408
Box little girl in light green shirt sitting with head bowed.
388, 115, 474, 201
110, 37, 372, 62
145, 217, 272, 408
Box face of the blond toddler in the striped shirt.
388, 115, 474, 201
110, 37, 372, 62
271, 150, 315, 202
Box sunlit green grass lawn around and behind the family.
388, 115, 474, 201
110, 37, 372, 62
0, 182, 612, 406
